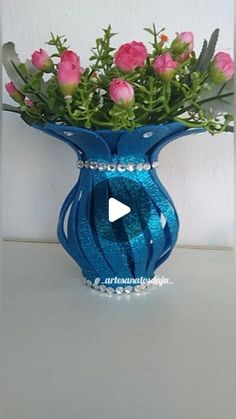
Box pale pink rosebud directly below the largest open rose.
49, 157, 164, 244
109, 79, 134, 105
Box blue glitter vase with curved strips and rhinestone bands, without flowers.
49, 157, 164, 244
35, 122, 202, 294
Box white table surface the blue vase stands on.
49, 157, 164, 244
2, 242, 235, 419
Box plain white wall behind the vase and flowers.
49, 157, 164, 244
3, 0, 233, 246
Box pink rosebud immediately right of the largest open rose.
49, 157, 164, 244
153, 52, 178, 81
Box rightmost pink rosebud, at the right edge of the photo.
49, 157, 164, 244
209, 52, 234, 84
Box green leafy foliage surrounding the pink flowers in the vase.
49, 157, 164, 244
3, 24, 233, 134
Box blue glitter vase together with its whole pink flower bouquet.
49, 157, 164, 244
3, 25, 234, 294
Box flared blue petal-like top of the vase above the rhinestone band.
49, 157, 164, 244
35, 122, 203, 163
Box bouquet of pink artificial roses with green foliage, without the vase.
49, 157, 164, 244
3, 25, 234, 134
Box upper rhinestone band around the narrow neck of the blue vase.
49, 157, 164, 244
76, 160, 159, 172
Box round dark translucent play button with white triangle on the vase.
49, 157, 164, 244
89, 175, 151, 243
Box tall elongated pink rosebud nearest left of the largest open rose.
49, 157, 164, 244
57, 61, 80, 98
